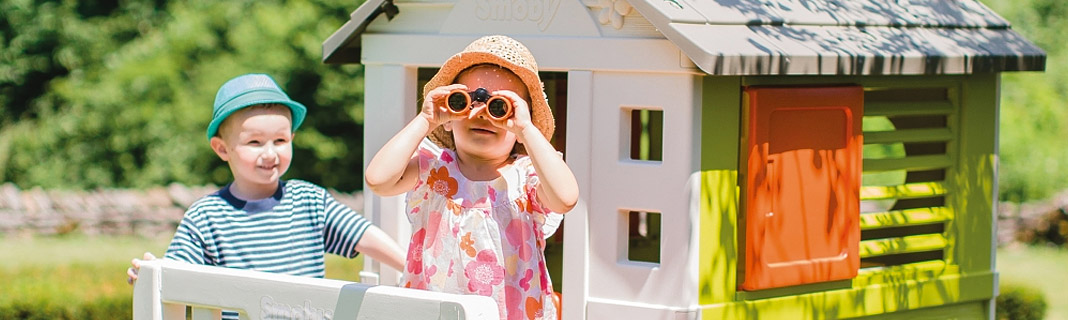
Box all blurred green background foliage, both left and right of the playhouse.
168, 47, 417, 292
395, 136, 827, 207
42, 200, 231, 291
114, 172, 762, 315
0, 0, 1068, 202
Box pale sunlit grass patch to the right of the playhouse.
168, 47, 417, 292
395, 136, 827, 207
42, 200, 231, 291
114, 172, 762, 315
998, 246, 1068, 319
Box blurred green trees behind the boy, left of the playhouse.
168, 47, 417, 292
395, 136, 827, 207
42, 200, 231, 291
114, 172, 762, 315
0, 0, 363, 191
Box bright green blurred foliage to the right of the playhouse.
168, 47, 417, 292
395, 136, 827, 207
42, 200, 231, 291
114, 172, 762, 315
981, 0, 1068, 203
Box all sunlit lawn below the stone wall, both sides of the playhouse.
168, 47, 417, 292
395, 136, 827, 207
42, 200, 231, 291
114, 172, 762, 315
6, 233, 1068, 319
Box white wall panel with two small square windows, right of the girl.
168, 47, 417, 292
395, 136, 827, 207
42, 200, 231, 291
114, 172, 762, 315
564, 71, 701, 319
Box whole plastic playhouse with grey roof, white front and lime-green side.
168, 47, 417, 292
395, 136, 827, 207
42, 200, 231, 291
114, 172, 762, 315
129, 0, 1046, 320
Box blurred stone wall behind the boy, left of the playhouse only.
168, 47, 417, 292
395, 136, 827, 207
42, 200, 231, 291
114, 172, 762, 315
0, 183, 363, 237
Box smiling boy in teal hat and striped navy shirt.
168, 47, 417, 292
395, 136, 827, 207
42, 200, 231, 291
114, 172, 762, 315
127, 75, 405, 309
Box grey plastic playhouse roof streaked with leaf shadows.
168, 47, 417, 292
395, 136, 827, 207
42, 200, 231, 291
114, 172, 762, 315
323, 0, 1046, 76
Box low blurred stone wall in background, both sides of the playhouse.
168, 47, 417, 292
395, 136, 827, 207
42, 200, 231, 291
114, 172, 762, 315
0, 182, 1068, 246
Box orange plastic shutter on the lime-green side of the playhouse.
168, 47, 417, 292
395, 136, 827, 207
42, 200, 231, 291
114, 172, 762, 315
740, 86, 864, 290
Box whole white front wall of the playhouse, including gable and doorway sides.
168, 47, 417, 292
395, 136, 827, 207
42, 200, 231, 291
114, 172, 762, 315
360, 0, 704, 319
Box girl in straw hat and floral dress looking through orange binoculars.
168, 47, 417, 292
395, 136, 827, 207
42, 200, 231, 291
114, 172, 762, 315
365, 35, 579, 319
